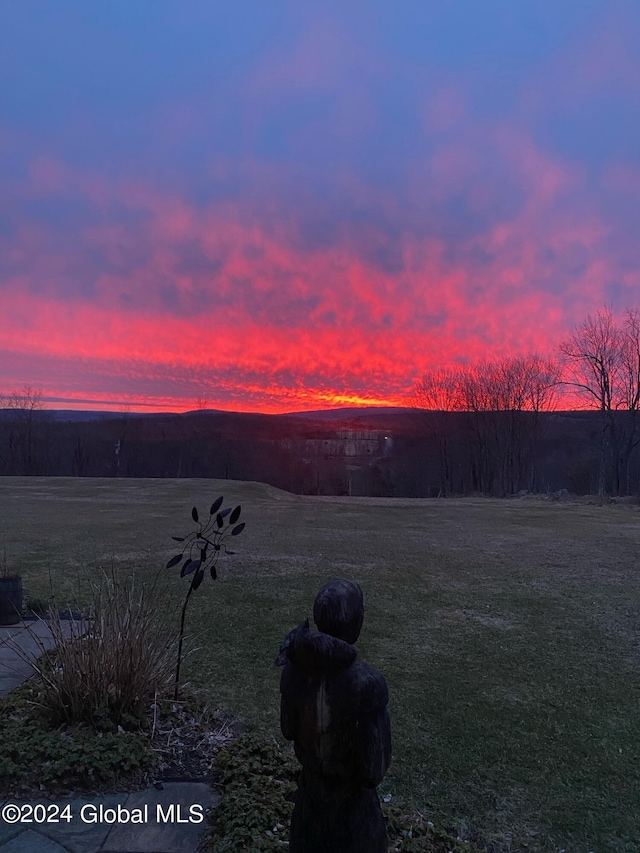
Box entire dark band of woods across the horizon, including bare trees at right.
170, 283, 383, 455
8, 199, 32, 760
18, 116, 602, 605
0, 306, 640, 497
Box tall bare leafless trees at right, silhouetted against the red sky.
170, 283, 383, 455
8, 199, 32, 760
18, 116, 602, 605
413, 306, 640, 495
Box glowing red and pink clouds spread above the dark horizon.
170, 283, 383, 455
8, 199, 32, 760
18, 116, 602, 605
0, 112, 638, 411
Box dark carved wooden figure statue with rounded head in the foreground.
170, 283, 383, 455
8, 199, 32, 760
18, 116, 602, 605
276, 579, 391, 853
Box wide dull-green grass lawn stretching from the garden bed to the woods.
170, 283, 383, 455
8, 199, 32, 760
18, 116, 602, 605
0, 478, 640, 853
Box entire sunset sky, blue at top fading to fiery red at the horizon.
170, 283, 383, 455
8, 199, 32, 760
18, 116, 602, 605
0, 0, 640, 412
